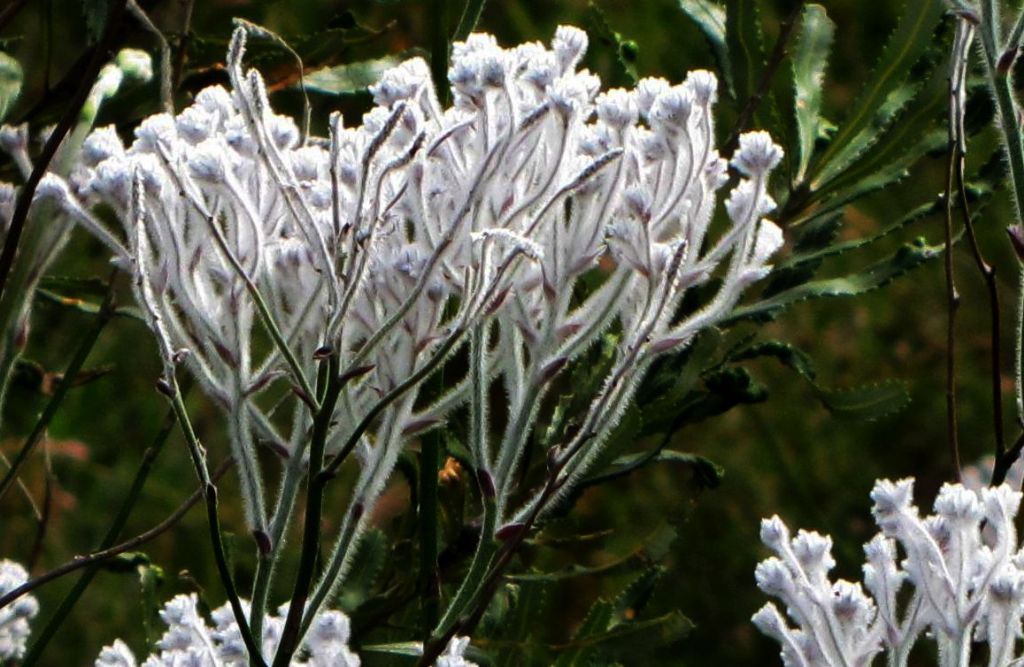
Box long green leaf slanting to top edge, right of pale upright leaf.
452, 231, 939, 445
810, 0, 945, 190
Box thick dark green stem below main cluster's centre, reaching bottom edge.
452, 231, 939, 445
273, 355, 344, 667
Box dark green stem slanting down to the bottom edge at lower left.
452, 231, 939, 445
22, 387, 188, 667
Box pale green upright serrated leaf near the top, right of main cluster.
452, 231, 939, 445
793, 4, 836, 182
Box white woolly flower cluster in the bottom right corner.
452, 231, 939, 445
753, 480, 1024, 667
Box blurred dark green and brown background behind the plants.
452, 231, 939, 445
0, 0, 1017, 665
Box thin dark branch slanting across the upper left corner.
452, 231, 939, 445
0, 0, 126, 299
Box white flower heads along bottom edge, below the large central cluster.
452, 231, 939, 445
96, 593, 476, 667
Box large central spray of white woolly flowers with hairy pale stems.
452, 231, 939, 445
32, 27, 782, 643
